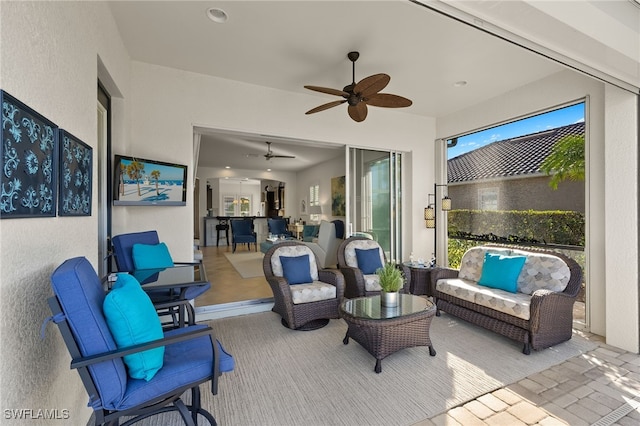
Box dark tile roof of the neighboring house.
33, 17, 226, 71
447, 123, 584, 183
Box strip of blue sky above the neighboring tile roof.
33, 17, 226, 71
447, 103, 584, 159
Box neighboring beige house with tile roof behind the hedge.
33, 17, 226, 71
447, 123, 585, 213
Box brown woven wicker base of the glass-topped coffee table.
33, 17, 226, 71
342, 306, 436, 373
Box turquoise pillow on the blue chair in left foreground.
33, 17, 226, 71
102, 273, 164, 381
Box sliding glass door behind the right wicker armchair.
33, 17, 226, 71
347, 148, 402, 260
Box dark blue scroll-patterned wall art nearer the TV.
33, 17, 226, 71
58, 129, 93, 216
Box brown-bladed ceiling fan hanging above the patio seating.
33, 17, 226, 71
304, 52, 413, 122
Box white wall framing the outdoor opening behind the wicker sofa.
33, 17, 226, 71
437, 70, 640, 352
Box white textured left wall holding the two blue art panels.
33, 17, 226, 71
0, 1, 128, 425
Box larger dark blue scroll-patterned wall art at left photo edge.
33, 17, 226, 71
0, 90, 58, 219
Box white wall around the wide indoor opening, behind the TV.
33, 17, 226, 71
121, 61, 435, 258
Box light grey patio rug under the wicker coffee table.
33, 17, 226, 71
189, 312, 596, 426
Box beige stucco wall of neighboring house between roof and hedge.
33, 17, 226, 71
448, 176, 585, 213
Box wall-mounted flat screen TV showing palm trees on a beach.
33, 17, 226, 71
113, 155, 187, 206
